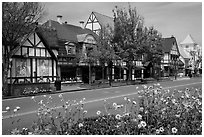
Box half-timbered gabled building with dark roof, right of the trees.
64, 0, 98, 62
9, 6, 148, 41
161, 36, 180, 76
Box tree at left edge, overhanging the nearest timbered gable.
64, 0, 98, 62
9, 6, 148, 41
2, 2, 45, 95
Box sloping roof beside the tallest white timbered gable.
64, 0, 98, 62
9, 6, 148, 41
92, 12, 114, 28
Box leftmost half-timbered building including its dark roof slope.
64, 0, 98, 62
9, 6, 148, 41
8, 27, 57, 95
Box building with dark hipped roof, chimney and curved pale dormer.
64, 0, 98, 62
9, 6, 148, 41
43, 16, 97, 83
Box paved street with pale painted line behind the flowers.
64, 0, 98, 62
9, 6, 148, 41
2, 78, 202, 134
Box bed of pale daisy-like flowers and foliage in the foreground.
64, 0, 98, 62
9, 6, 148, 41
7, 84, 202, 135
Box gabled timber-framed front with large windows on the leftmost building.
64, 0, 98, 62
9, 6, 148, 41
8, 32, 57, 94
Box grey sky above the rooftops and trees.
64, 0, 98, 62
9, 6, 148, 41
42, 1, 202, 45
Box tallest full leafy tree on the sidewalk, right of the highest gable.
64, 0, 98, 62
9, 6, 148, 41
113, 6, 144, 80
